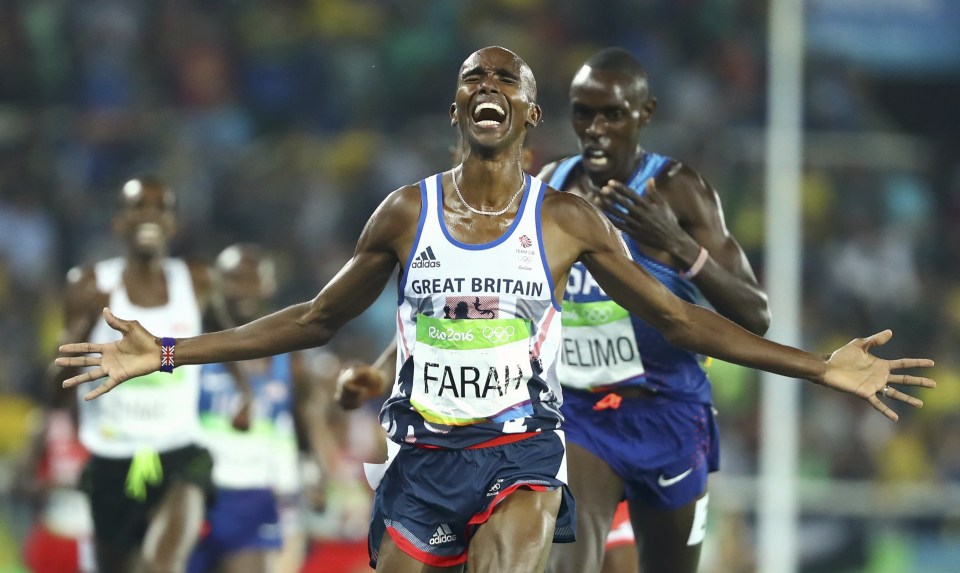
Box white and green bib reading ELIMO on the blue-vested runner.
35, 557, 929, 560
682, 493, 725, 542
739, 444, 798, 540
560, 300, 644, 390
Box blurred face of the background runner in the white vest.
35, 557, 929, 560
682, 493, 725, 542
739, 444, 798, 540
113, 179, 176, 256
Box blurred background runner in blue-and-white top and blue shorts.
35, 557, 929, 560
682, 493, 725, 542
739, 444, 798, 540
187, 244, 310, 573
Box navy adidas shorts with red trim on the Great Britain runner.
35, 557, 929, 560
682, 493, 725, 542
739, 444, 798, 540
368, 432, 576, 567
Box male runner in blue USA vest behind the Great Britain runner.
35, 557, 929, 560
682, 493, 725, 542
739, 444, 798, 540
540, 48, 770, 573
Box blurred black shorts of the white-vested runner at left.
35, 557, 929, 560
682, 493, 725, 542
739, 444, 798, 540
81, 445, 214, 551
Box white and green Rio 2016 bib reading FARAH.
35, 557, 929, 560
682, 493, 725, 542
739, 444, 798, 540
410, 314, 532, 426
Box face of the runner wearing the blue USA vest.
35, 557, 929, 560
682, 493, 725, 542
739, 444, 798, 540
570, 67, 655, 181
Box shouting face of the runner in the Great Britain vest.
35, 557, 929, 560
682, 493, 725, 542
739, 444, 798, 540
450, 48, 540, 153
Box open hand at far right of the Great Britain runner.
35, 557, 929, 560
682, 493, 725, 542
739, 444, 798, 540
820, 330, 937, 421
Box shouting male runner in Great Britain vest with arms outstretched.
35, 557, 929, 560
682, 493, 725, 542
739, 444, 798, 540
57, 47, 934, 573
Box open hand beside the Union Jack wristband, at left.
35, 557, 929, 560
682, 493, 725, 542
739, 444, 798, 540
56, 308, 160, 400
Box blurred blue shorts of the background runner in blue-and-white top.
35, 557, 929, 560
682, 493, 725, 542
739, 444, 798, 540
187, 489, 283, 573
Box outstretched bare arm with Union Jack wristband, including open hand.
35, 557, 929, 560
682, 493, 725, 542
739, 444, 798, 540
56, 185, 420, 399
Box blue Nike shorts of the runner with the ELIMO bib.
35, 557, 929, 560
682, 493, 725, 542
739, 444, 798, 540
561, 388, 720, 509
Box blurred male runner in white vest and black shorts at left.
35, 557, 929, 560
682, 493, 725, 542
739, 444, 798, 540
53, 176, 213, 573
